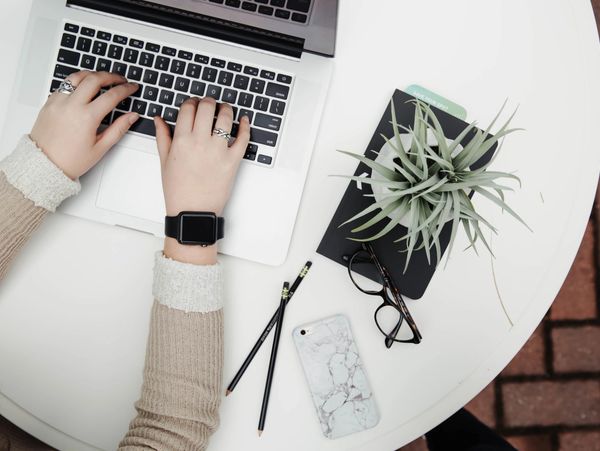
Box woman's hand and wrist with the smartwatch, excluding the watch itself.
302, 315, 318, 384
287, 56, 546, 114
154, 97, 250, 264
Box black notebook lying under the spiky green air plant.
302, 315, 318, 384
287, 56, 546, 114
317, 90, 497, 299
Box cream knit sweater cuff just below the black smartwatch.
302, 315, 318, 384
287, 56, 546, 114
152, 252, 223, 313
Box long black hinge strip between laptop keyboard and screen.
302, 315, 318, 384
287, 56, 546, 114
67, 0, 304, 58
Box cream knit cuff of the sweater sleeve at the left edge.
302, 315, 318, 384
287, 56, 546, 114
0, 135, 81, 212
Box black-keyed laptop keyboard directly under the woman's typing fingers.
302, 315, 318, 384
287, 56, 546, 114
50, 23, 293, 166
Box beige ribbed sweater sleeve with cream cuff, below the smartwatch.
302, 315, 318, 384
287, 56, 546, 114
119, 253, 223, 451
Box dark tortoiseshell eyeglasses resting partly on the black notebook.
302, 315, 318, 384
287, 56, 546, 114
343, 243, 423, 348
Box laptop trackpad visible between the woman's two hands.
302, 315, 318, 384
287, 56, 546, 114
96, 147, 165, 222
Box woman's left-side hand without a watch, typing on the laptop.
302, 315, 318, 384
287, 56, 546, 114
30, 71, 139, 180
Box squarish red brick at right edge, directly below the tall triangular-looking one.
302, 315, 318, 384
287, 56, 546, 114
552, 326, 600, 373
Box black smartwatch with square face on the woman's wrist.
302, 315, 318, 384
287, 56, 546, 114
165, 211, 225, 247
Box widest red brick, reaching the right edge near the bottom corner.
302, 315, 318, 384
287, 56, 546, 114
502, 381, 600, 427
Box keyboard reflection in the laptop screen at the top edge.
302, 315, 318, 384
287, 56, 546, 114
202, 0, 312, 24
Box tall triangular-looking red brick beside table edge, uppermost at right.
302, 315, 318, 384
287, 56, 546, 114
550, 222, 598, 319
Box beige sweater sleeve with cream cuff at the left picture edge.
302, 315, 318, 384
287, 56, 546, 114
0, 136, 80, 280
